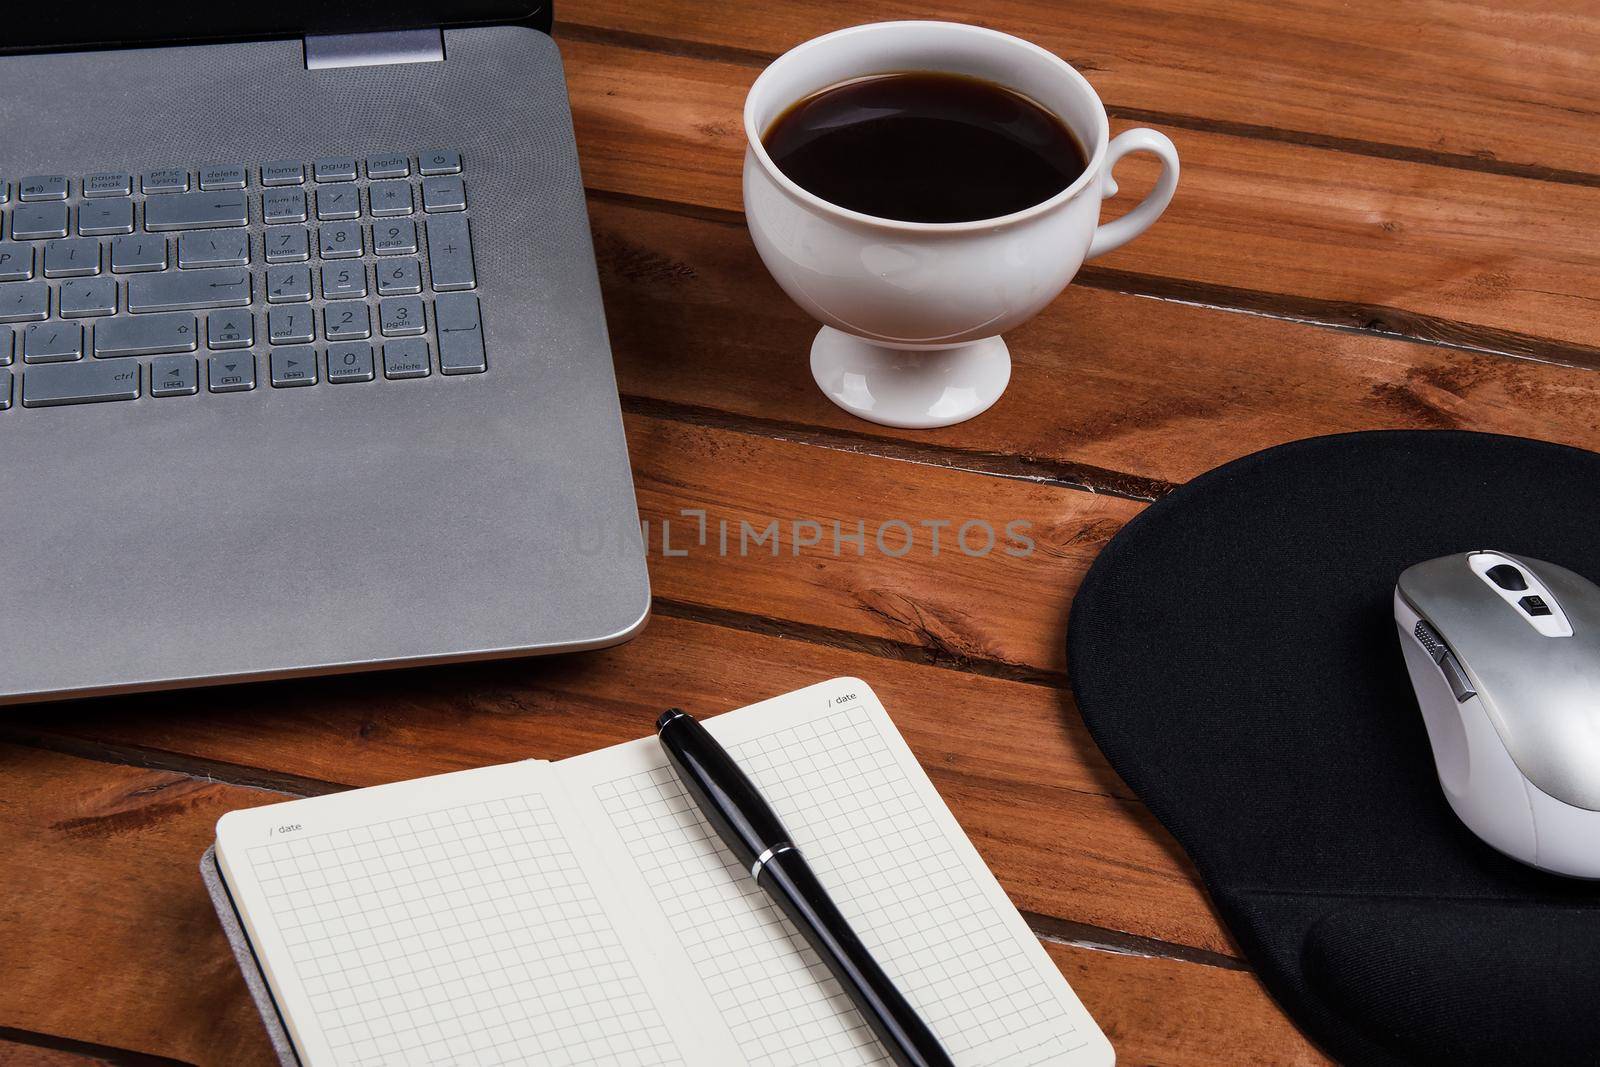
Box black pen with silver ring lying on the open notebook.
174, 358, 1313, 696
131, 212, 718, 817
656, 707, 954, 1067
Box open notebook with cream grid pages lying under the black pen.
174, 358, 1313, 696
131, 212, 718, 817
214, 678, 1114, 1067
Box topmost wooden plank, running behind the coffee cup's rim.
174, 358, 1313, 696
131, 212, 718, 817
557, 0, 1600, 184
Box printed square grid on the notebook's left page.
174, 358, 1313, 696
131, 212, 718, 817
248, 795, 683, 1067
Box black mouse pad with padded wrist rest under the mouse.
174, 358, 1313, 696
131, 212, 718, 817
1067, 430, 1600, 1067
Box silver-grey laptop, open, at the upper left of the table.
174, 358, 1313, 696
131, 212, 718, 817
0, 0, 650, 704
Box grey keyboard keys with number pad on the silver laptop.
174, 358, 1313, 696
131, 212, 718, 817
0, 150, 488, 411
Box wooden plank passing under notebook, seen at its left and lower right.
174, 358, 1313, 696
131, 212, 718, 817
0, 745, 1320, 1067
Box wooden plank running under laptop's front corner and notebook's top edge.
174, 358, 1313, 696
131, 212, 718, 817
3, 617, 1235, 953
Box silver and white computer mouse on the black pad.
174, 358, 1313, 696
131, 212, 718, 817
1394, 550, 1600, 878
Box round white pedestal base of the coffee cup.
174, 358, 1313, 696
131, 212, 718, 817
811, 326, 1011, 430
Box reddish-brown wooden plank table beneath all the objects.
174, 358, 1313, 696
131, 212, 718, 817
0, 0, 1600, 1065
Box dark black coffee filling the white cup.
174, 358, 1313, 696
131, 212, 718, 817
762, 72, 1088, 222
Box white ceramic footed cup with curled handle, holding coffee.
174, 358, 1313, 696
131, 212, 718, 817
744, 22, 1178, 429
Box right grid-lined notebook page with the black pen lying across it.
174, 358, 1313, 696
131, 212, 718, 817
594, 683, 1104, 1067
